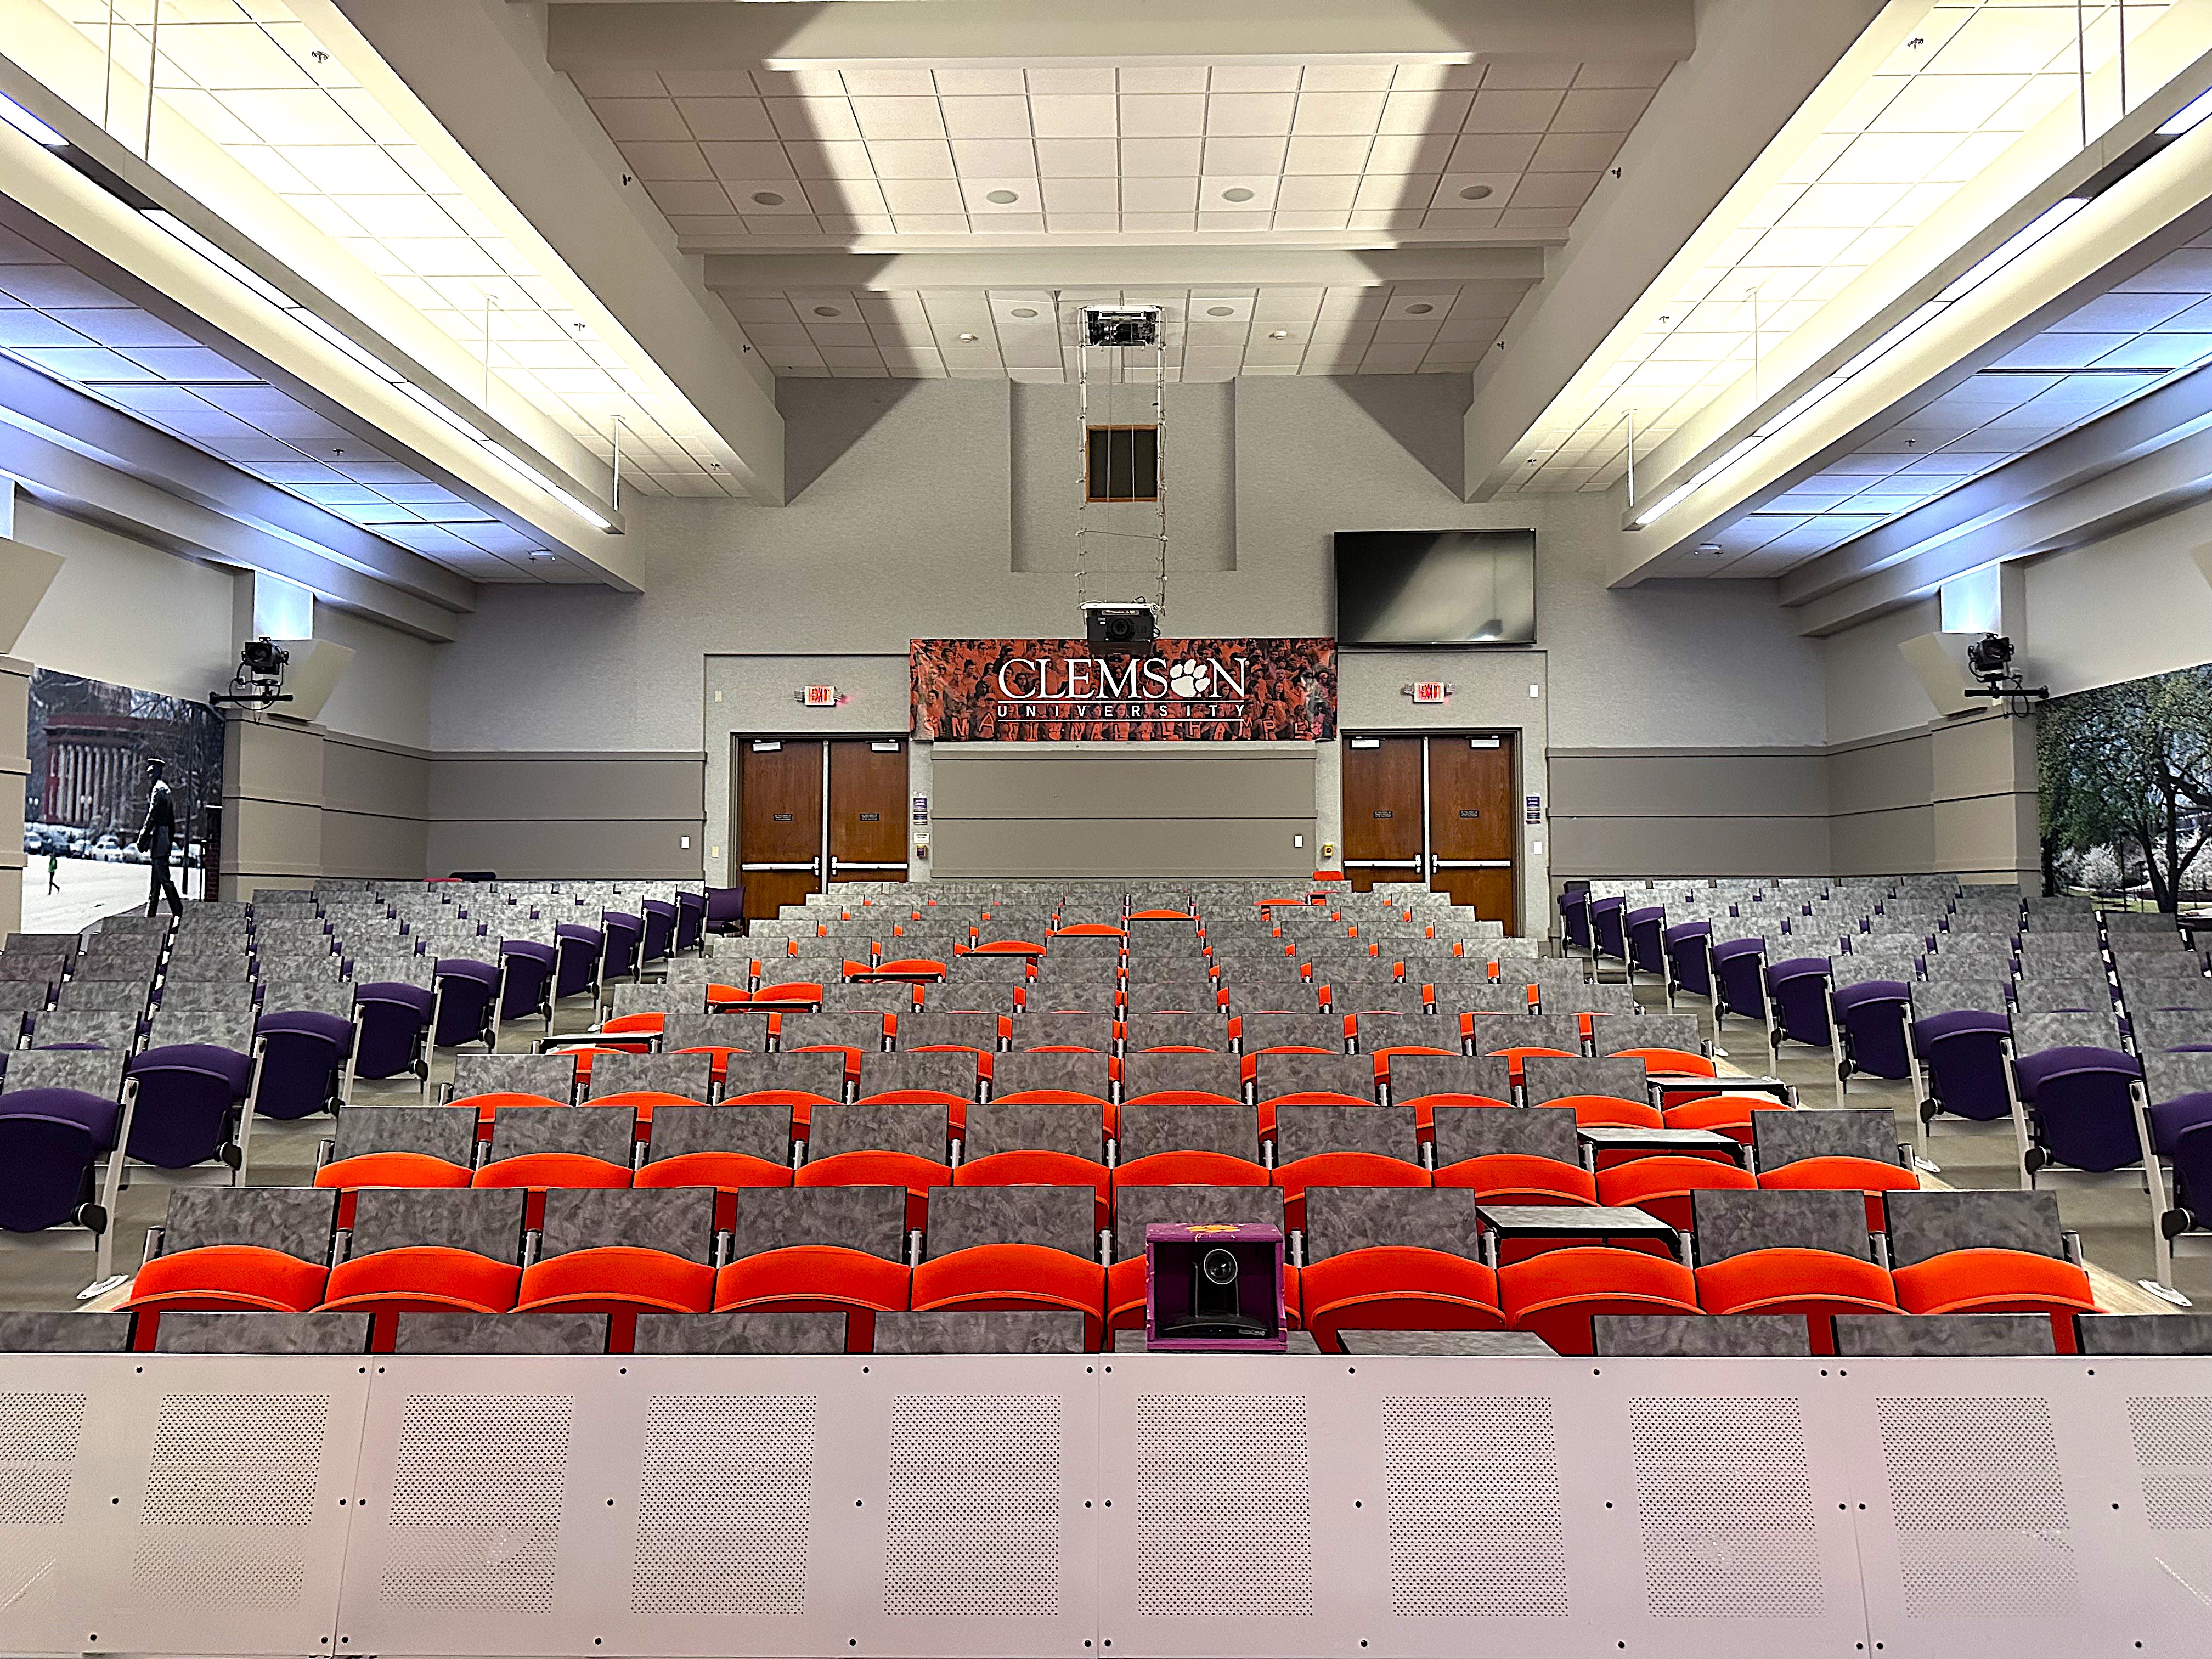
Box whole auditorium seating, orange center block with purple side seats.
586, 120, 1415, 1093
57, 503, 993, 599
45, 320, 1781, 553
0, 878, 2212, 1354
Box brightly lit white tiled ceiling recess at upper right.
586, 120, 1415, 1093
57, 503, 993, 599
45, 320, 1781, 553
1509, 0, 2212, 560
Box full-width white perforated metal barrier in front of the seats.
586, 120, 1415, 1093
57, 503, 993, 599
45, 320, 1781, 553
0, 1354, 2212, 1659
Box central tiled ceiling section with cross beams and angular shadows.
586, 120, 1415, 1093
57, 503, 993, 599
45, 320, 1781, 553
549, 0, 1692, 381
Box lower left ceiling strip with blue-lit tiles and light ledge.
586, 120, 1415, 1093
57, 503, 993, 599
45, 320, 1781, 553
0, 94, 628, 584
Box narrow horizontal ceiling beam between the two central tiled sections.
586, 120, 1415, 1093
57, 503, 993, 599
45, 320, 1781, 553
706, 242, 1544, 294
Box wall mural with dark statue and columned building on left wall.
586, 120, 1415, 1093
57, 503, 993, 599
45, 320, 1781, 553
22, 668, 223, 934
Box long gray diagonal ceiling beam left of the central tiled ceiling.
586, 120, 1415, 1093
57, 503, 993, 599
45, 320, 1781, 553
320, 0, 783, 506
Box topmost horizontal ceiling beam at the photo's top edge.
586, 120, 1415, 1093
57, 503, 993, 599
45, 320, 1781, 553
535, 0, 1690, 71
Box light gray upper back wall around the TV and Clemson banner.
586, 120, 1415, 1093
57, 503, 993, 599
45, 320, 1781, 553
427, 376, 1825, 891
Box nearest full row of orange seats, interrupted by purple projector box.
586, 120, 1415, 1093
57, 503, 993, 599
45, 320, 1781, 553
128, 1186, 2095, 1354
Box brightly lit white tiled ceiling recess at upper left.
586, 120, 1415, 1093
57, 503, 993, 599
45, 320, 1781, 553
9, 0, 770, 520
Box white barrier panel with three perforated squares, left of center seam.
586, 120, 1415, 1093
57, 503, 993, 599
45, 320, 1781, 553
338, 1356, 1097, 1659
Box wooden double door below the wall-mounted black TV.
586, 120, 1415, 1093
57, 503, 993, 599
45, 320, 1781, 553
1342, 732, 1520, 934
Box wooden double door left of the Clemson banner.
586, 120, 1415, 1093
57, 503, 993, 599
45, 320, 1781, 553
732, 737, 907, 918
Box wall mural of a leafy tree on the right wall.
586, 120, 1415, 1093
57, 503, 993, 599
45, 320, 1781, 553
2037, 664, 2212, 911
